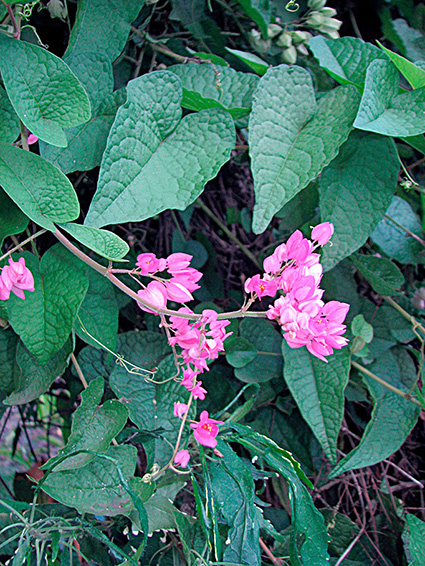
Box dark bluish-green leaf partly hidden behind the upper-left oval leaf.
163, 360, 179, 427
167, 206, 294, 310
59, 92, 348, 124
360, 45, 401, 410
40, 53, 126, 173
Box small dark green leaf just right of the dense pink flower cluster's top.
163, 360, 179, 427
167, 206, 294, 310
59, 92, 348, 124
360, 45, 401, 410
351, 254, 404, 296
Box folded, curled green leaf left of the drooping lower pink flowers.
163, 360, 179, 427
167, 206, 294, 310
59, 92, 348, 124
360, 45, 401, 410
43, 377, 128, 473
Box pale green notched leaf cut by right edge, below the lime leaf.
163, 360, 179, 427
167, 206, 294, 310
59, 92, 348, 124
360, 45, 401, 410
354, 60, 425, 137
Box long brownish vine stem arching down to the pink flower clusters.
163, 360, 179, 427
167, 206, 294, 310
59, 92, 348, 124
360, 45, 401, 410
54, 228, 267, 320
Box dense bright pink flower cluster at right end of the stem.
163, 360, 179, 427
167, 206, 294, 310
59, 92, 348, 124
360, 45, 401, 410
245, 222, 350, 362
